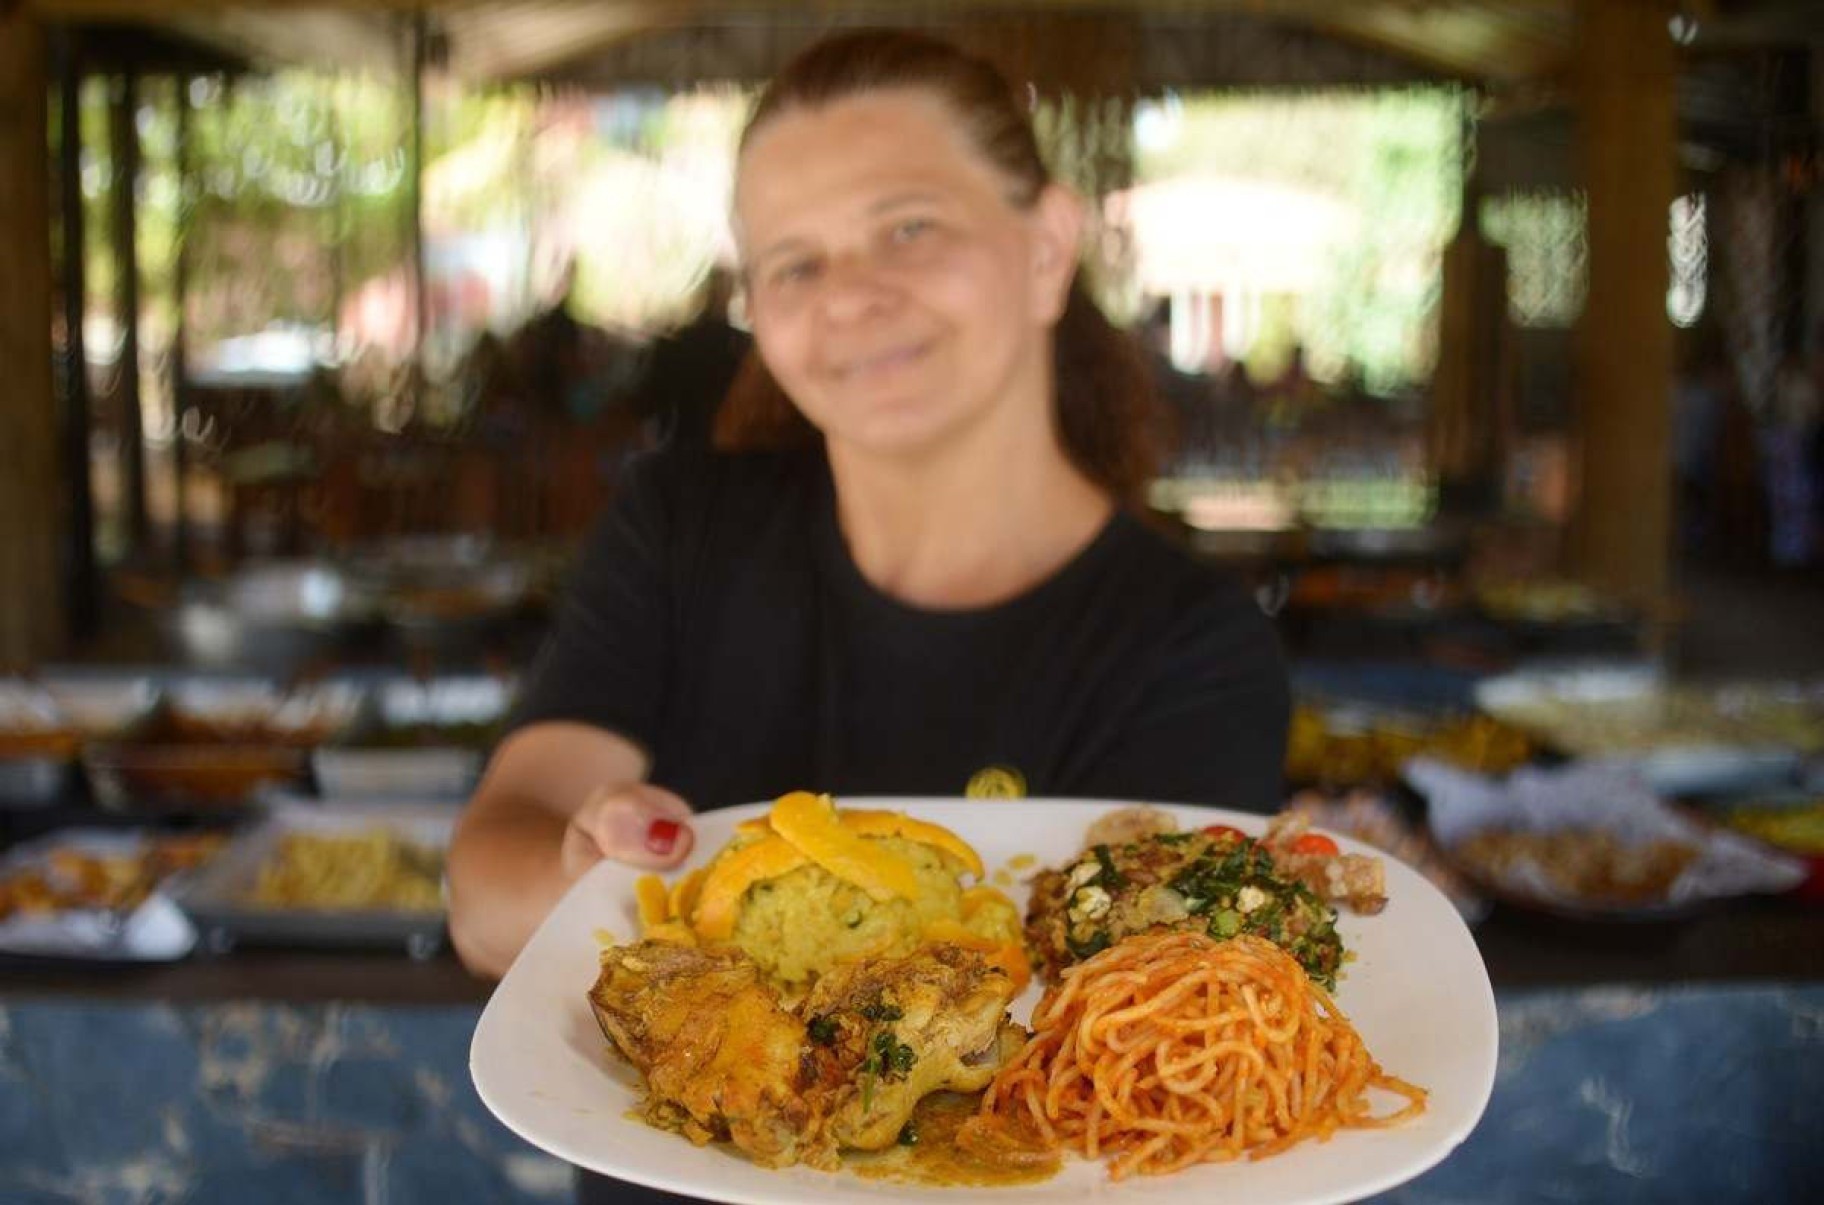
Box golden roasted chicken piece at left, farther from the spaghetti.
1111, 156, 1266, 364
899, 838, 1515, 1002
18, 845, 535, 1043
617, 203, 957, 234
589, 941, 835, 1167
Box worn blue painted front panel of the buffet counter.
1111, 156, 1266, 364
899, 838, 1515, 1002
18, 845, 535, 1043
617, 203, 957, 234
0, 981, 1824, 1205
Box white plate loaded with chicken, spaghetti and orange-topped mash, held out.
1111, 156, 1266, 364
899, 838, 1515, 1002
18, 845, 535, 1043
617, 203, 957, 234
471, 793, 1498, 1205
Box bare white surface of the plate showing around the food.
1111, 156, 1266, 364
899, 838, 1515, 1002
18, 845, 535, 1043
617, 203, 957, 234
469, 798, 1496, 1205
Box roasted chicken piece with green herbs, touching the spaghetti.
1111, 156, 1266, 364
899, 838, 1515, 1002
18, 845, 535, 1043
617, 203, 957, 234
799, 946, 1025, 1150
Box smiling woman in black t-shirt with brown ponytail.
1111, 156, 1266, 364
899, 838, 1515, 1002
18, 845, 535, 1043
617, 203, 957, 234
451, 33, 1288, 975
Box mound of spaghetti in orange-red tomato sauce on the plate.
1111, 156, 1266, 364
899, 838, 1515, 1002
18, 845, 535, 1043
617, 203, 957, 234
959, 932, 1426, 1179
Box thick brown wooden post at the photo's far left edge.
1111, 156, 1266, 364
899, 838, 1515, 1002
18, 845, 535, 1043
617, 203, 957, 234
0, 0, 64, 665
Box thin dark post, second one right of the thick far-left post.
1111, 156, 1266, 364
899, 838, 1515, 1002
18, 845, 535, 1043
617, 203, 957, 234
108, 67, 151, 554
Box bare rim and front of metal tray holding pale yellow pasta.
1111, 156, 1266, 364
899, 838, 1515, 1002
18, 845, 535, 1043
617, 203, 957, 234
170, 800, 456, 959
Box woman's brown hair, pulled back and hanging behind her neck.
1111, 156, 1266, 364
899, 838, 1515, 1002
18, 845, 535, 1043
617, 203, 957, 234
715, 29, 1156, 501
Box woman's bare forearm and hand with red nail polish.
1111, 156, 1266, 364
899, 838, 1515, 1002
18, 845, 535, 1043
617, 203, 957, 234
449, 722, 691, 977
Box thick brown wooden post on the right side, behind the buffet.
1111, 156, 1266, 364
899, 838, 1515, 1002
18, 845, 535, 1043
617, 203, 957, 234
1570, 0, 1678, 614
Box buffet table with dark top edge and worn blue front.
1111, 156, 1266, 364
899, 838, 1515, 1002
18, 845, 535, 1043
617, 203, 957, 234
0, 899, 1824, 1205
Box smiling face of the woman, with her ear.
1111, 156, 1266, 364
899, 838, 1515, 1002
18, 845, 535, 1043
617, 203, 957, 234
735, 89, 1080, 456
